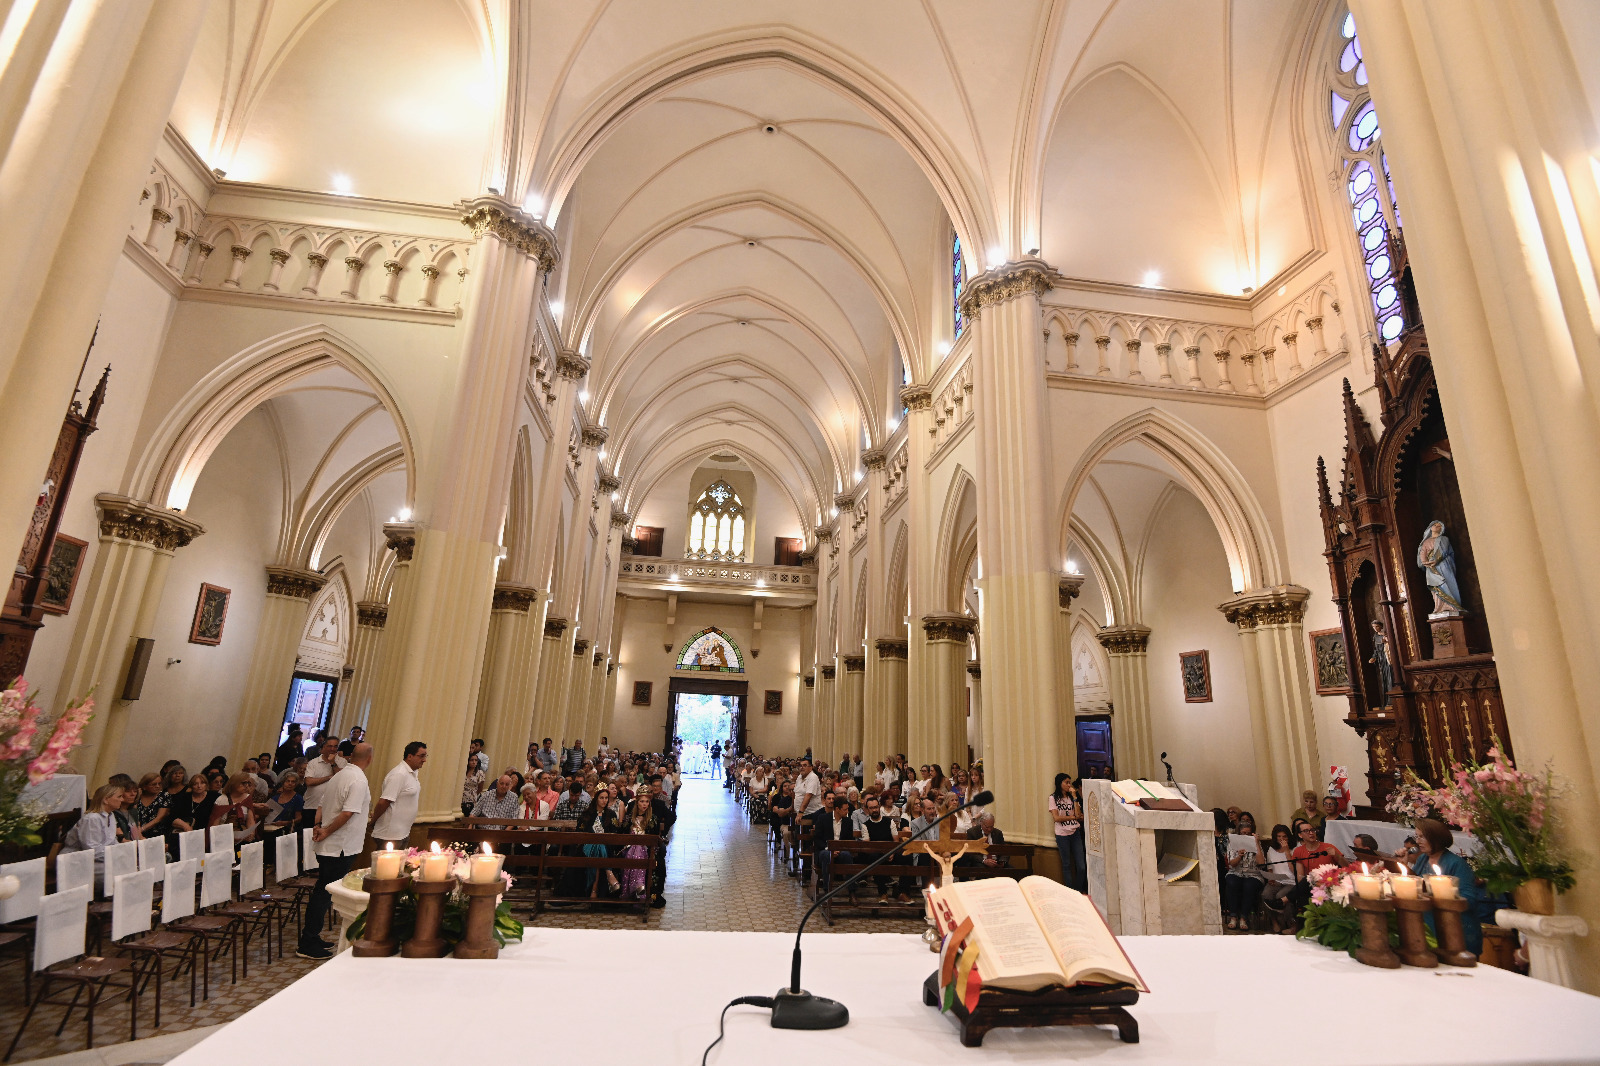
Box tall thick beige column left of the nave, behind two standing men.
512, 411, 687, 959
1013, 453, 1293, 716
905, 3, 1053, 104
374, 195, 557, 823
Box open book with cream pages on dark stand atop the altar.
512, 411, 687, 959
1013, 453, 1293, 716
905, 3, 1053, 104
930, 876, 1150, 992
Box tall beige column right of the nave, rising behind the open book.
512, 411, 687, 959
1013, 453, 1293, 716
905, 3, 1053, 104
962, 258, 1061, 845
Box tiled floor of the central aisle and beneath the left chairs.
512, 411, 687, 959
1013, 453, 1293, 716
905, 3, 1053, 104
0, 778, 922, 1066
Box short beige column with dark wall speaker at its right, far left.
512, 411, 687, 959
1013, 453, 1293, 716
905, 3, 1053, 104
56, 485, 205, 783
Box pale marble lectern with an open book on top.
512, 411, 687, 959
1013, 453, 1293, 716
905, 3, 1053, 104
1080, 779, 1222, 936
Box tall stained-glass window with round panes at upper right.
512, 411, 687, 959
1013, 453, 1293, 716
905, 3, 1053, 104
1328, 14, 1406, 341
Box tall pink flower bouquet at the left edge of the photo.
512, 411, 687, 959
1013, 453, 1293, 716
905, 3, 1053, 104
0, 677, 94, 847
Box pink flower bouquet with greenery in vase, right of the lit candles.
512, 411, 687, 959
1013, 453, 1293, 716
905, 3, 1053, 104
1432, 746, 1578, 893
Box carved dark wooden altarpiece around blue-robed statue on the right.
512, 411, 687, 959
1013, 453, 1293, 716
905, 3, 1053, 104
1317, 235, 1510, 806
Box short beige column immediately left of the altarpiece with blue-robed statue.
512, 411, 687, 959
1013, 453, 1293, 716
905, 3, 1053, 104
1219, 584, 1325, 812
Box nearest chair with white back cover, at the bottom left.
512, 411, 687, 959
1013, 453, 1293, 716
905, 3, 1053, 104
0, 883, 139, 1061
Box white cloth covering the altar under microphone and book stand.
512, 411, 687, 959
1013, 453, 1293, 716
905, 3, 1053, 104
173, 925, 1600, 1066
